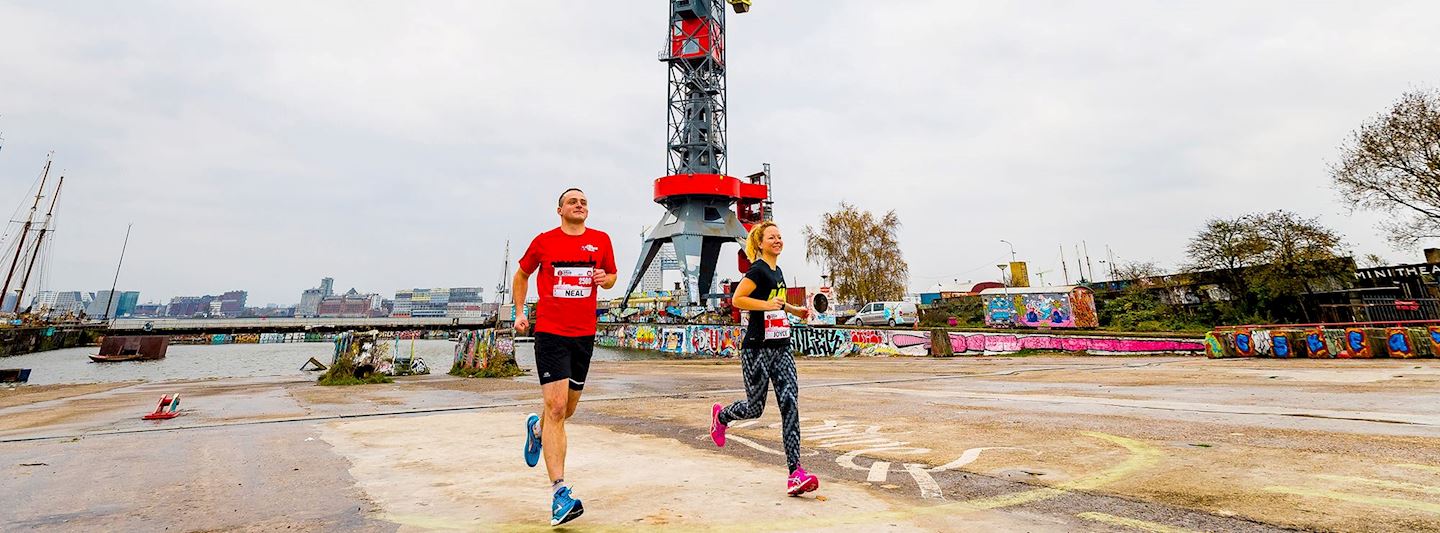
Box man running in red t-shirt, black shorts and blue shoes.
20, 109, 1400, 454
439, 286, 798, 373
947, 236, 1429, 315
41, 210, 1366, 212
511, 189, 615, 526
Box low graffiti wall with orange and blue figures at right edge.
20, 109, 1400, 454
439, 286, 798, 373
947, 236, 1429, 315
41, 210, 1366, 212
1205, 326, 1440, 359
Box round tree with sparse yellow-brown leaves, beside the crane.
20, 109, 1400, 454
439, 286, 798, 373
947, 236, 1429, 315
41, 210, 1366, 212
804, 202, 910, 304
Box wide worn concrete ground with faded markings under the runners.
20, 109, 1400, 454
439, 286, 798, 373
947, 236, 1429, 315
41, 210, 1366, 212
0, 356, 1440, 532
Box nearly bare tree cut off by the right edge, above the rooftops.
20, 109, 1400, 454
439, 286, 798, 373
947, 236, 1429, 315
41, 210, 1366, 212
1331, 91, 1440, 245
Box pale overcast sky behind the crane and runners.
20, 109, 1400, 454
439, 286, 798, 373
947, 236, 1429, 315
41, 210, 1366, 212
0, 0, 1440, 305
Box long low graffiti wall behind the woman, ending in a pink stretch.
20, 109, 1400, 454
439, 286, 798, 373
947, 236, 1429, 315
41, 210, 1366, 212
595, 324, 1203, 357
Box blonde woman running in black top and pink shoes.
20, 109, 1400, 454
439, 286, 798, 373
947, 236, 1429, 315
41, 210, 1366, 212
710, 220, 819, 496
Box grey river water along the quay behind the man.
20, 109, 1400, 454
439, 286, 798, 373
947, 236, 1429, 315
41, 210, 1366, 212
0, 340, 664, 385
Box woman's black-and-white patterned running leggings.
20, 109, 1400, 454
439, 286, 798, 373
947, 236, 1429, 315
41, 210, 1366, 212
720, 346, 801, 472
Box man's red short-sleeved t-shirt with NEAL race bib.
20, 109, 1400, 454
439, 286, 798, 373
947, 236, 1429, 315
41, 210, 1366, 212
520, 228, 615, 337
